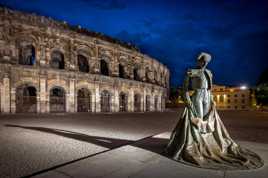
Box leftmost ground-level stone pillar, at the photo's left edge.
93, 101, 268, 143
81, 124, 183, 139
1, 76, 10, 113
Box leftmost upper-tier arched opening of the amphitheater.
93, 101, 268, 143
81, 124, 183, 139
19, 45, 35, 65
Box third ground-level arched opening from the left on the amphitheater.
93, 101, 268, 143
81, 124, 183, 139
77, 88, 91, 112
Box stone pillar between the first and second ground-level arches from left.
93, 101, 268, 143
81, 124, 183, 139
39, 77, 46, 113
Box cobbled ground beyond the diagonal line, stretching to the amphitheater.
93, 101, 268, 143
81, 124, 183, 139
0, 110, 268, 177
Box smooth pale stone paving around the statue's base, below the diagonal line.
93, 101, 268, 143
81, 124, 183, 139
33, 133, 268, 178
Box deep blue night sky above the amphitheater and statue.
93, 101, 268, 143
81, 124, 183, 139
0, 0, 268, 85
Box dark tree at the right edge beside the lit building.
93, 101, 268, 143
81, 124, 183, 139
255, 68, 268, 106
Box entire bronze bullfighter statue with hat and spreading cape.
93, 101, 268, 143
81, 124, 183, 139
165, 53, 263, 170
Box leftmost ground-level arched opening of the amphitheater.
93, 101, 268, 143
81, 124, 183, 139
16, 85, 37, 113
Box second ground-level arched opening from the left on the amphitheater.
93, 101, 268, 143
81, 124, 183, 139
49, 87, 66, 112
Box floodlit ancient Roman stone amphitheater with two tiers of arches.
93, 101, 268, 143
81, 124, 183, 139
0, 7, 170, 113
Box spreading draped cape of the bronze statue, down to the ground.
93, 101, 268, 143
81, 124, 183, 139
166, 106, 263, 170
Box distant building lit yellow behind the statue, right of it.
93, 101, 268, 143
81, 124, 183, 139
212, 85, 252, 110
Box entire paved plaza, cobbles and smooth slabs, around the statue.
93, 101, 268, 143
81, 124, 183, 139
0, 109, 268, 178
